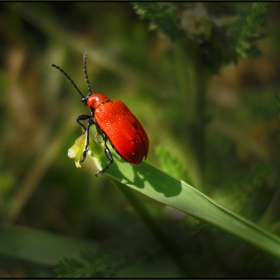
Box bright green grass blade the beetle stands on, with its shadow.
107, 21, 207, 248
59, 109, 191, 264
95, 156, 280, 257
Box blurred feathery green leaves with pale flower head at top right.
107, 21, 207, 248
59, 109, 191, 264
134, 2, 268, 72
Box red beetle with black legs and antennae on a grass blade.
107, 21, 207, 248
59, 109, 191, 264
52, 53, 149, 176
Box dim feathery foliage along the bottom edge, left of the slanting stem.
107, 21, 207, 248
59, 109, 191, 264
56, 227, 165, 278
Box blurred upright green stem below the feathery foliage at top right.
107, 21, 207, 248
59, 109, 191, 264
174, 39, 210, 190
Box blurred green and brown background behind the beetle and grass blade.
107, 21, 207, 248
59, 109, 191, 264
0, 2, 280, 277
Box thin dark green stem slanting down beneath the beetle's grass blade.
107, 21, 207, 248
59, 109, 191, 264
110, 178, 191, 277
